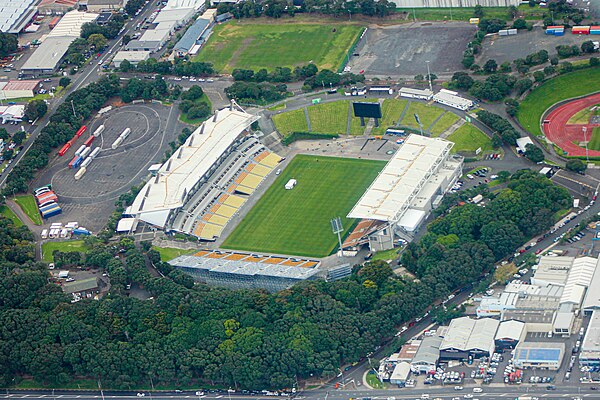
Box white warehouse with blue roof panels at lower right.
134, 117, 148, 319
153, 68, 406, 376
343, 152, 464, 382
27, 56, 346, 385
514, 342, 565, 371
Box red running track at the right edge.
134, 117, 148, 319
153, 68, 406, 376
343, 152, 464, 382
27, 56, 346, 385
542, 93, 600, 157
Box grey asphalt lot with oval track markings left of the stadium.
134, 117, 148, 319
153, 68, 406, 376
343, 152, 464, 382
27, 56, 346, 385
34, 104, 183, 231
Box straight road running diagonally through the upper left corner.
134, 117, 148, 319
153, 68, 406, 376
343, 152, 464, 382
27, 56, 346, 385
0, 2, 154, 187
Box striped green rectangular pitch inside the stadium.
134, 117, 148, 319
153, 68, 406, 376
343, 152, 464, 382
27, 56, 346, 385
222, 155, 385, 257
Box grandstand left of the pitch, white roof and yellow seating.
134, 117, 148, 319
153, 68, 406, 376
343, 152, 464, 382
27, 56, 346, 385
129, 104, 282, 241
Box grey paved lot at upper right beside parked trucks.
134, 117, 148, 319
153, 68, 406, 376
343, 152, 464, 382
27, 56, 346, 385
476, 27, 590, 65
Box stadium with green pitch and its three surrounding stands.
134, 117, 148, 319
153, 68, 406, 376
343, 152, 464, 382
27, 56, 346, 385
125, 102, 462, 291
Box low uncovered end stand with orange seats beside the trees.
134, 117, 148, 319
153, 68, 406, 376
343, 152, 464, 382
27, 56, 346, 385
169, 251, 320, 292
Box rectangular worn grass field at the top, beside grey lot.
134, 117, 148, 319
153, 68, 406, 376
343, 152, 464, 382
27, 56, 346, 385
194, 20, 362, 72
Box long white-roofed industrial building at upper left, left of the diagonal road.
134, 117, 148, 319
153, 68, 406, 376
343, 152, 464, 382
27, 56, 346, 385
20, 11, 98, 77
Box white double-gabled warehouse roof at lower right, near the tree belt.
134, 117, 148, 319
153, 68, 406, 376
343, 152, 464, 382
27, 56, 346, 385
440, 317, 500, 353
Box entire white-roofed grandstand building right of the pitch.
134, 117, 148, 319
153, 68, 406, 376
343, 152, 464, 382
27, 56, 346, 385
348, 134, 463, 251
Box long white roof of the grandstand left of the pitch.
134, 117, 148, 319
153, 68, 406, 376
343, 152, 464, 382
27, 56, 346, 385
131, 109, 258, 226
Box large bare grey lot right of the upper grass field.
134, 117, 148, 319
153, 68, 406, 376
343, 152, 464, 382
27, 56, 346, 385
348, 23, 475, 78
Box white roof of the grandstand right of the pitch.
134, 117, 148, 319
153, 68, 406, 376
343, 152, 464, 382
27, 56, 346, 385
348, 134, 453, 221
